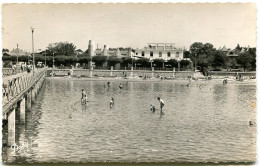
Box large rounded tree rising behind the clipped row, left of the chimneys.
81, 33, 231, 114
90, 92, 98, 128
47, 42, 76, 56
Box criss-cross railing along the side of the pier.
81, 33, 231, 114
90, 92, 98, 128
2, 68, 46, 107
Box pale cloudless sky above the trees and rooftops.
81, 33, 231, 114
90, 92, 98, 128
2, 3, 256, 52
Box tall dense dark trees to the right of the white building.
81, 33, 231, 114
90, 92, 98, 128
189, 42, 256, 71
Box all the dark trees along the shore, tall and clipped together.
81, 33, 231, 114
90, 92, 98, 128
2, 42, 256, 71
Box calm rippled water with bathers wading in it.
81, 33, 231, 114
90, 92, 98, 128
3, 78, 256, 162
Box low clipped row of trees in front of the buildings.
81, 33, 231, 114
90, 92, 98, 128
2, 55, 190, 69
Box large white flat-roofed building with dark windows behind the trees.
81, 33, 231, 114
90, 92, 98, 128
134, 43, 184, 61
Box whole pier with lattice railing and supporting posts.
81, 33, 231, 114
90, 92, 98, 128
2, 68, 47, 146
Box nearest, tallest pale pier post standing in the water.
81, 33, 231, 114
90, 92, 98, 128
7, 108, 15, 146
